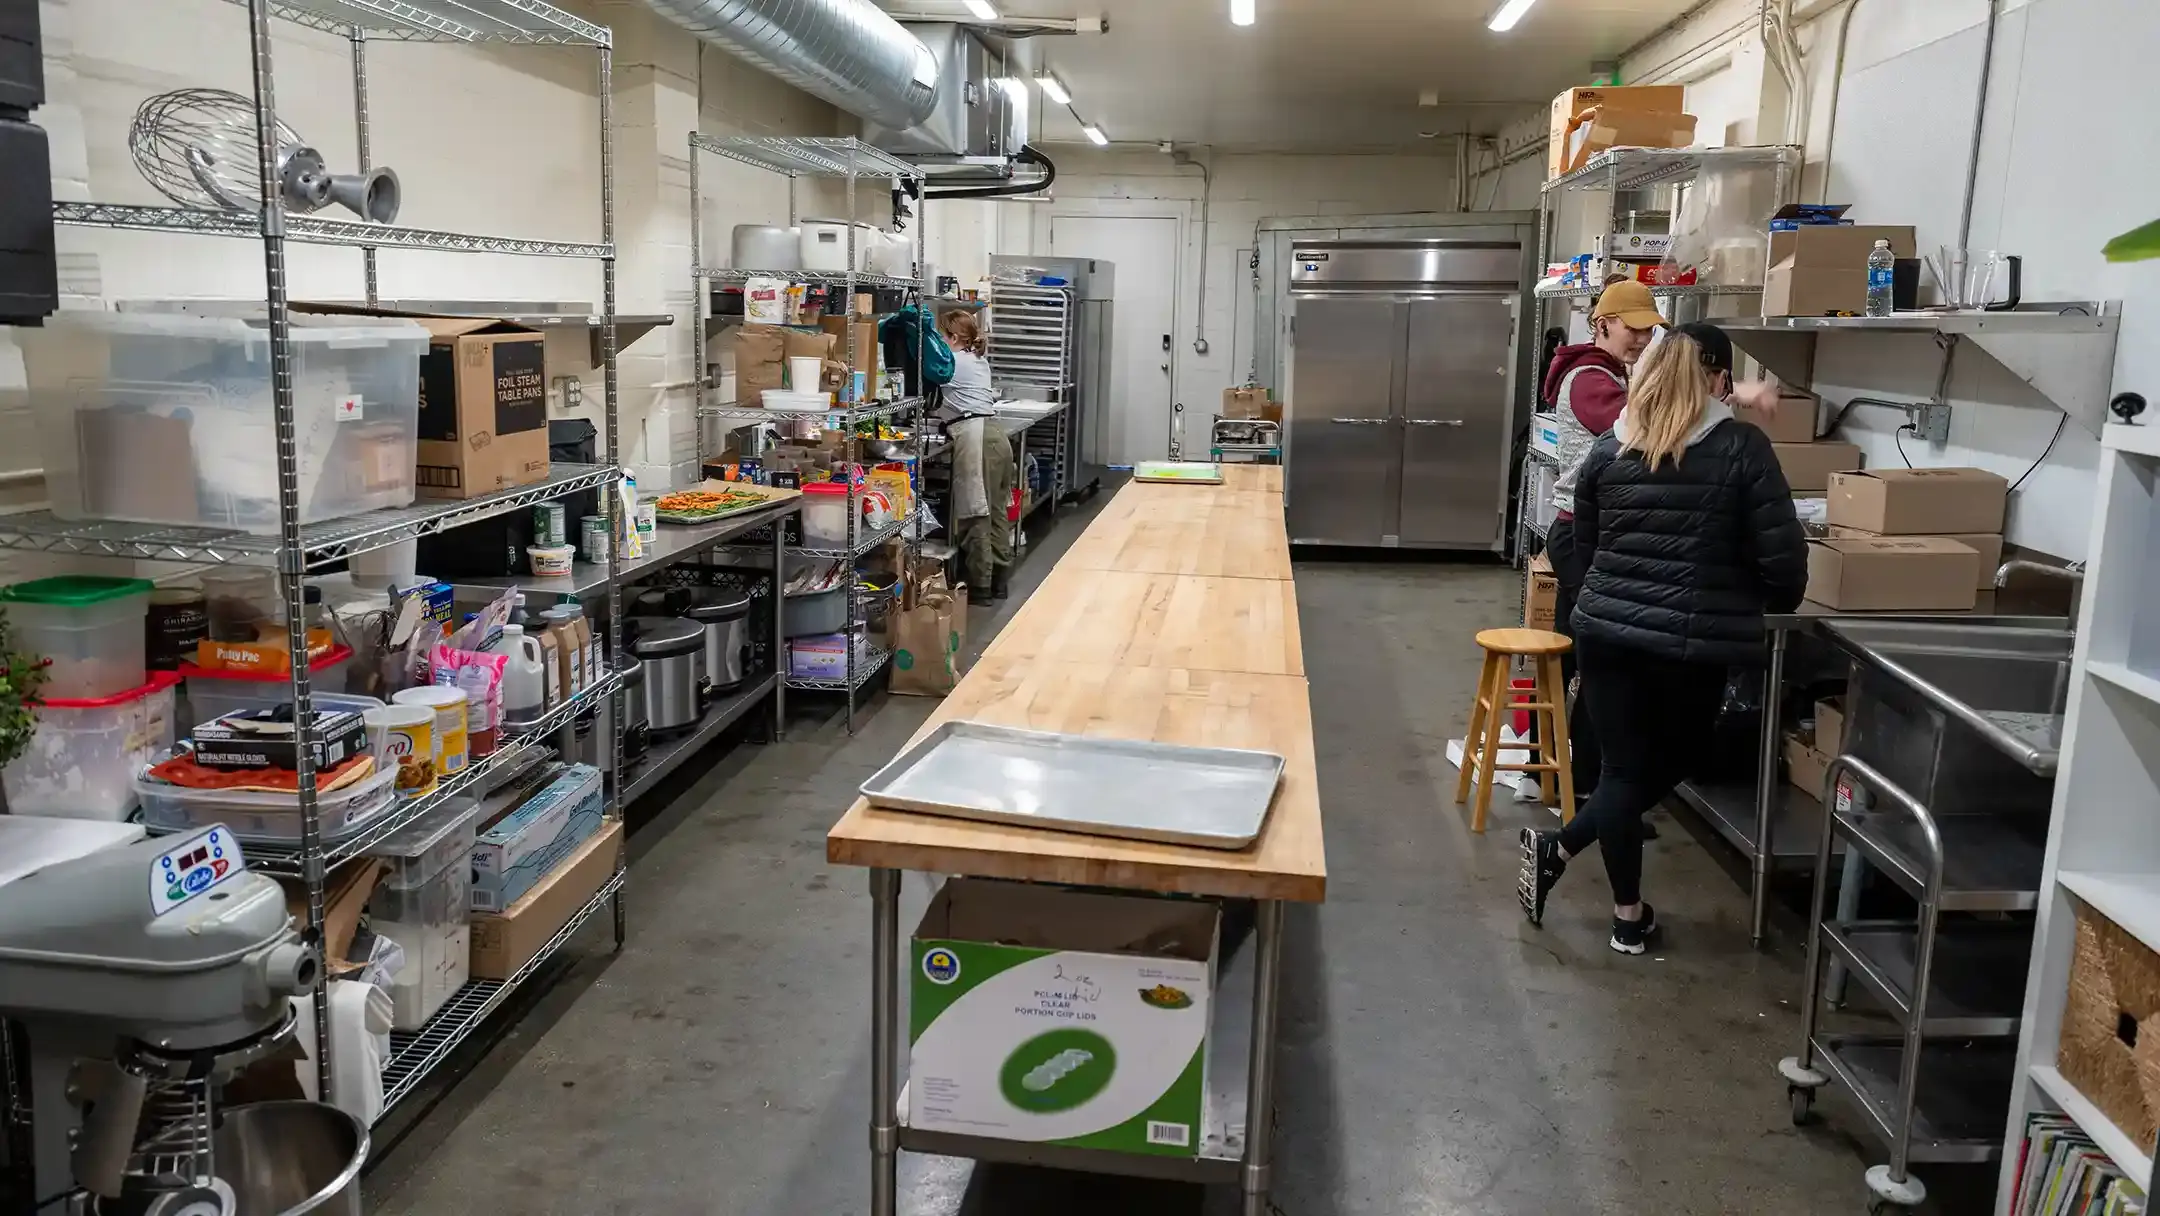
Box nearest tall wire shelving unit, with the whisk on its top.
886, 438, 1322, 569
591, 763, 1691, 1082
31, 0, 626, 1114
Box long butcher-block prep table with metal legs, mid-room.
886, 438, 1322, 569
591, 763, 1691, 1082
825, 464, 1326, 1216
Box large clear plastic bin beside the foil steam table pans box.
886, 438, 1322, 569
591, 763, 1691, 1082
15, 311, 428, 536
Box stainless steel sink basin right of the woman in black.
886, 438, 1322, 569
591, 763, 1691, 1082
1821, 618, 2076, 775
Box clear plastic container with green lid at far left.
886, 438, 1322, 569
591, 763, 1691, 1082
0, 575, 153, 700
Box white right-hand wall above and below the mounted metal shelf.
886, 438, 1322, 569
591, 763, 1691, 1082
1622, 0, 2160, 557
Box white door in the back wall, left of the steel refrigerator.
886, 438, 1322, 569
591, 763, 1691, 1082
1050, 216, 1177, 464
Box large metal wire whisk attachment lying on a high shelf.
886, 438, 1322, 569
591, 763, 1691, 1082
127, 89, 400, 225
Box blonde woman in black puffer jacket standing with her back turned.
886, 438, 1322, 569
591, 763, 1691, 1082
1521, 324, 1808, 955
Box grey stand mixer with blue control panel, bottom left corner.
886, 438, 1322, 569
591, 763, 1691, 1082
0, 827, 345, 1216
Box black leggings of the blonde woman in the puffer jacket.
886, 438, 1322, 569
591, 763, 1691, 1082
1560, 637, 1726, 907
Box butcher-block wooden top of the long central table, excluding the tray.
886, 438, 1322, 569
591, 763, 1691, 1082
825, 464, 1326, 901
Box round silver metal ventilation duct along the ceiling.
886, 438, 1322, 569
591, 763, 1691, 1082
646, 0, 937, 130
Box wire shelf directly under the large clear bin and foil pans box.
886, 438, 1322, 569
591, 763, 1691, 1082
0, 462, 622, 570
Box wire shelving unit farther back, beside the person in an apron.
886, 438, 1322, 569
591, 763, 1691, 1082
689, 132, 929, 734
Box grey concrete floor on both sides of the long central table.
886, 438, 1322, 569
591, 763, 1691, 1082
369, 496, 1992, 1216
